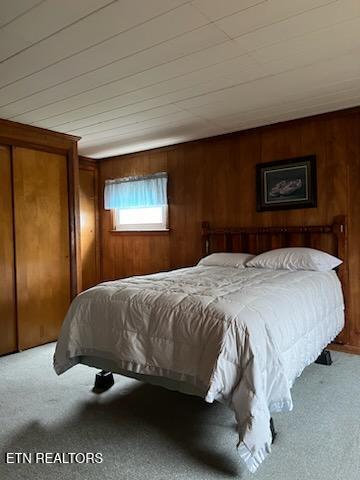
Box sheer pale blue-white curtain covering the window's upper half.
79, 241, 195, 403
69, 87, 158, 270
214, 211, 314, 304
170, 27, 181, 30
104, 172, 167, 210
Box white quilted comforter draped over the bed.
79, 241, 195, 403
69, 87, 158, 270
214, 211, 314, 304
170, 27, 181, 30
54, 266, 344, 472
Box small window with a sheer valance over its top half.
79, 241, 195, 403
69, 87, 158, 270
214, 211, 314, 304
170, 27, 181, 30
104, 173, 168, 231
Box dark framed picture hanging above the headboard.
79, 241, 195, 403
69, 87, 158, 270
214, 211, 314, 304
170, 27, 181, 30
256, 155, 317, 212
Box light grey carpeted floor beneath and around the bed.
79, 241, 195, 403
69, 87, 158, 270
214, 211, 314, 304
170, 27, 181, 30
0, 344, 360, 480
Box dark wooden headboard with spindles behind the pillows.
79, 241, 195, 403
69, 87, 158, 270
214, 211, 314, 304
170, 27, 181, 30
202, 215, 349, 343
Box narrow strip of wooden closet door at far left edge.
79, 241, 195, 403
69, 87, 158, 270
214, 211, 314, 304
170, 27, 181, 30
0, 146, 17, 355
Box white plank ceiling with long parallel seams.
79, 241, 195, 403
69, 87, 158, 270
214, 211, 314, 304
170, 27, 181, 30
0, 0, 360, 158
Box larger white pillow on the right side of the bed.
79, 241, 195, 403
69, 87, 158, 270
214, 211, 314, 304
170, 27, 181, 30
246, 247, 342, 272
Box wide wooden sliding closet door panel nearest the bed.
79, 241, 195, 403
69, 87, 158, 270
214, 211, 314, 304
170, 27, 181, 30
13, 147, 70, 349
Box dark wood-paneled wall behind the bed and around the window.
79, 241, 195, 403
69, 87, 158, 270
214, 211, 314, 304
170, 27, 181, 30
99, 109, 360, 347
